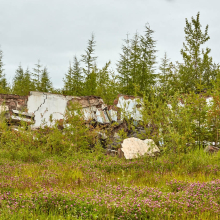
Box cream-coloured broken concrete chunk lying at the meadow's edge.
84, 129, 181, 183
121, 137, 160, 159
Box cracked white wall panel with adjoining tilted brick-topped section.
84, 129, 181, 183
27, 92, 110, 128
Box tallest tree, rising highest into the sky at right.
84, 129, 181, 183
179, 13, 216, 93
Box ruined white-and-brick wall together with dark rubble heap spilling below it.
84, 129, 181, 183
0, 92, 153, 157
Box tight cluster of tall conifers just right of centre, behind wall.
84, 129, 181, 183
117, 24, 156, 95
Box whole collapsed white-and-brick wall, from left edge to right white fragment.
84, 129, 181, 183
0, 92, 141, 128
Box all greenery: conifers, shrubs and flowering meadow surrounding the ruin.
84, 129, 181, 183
0, 13, 220, 220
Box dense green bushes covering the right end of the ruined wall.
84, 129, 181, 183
142, 89, 220, 154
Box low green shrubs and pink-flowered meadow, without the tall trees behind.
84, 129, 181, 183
0, 90, 220, 219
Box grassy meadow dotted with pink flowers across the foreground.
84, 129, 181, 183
0, 147, 220, 219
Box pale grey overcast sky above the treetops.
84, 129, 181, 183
0, 0, 220, 88
